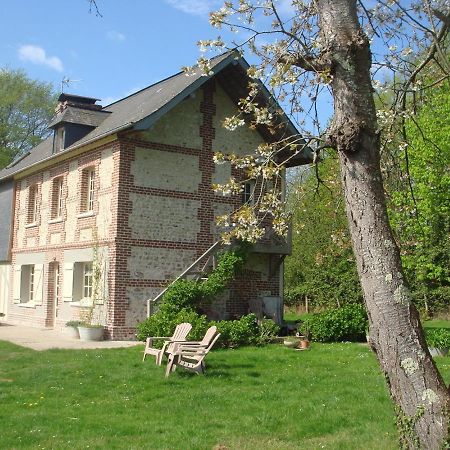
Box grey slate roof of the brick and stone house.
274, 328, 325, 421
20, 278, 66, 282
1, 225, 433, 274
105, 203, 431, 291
0, 52, 307, 180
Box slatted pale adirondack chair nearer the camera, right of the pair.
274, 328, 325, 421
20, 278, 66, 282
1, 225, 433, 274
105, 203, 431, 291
166, 326, 220, 377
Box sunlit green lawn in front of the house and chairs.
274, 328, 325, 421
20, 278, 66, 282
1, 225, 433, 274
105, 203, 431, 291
0, 341, 450, 450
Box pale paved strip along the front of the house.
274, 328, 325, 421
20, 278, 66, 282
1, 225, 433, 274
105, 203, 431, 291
0, 322, 143, 350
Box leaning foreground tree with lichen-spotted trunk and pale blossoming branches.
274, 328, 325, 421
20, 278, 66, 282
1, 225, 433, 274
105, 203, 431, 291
193, 0, 450, 449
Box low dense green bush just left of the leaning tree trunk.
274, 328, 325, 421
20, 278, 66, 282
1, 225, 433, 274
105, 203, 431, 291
300, 304, 367, 342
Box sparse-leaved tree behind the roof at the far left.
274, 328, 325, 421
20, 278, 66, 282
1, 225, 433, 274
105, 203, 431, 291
0, 69, 56, 168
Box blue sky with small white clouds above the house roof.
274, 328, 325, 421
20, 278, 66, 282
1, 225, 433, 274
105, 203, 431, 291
0, 0, 229, 105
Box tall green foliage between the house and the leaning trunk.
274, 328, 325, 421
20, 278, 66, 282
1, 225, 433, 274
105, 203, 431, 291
285, 155, 362, 307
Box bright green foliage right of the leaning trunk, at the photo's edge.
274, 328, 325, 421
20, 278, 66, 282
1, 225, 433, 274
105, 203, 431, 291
386, 82, 450, 316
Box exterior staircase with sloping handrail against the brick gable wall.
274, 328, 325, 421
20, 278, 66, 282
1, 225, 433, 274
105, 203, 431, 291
147, 240, 224, 317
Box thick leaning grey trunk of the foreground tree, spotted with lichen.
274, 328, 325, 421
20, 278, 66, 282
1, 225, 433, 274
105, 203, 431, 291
317, 0, 449, 449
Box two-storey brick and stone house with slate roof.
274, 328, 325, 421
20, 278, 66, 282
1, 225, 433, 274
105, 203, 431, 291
0, 53, 310, 339
